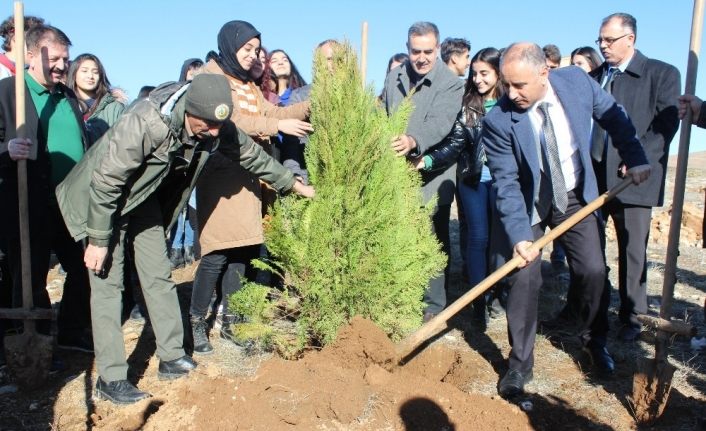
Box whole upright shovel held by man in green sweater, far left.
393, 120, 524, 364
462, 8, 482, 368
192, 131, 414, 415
2, 1, 53, 389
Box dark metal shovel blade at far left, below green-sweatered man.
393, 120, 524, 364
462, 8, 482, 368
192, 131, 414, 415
5, 331, 52, 389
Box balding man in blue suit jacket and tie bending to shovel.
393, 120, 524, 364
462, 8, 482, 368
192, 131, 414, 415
482, 43, 650, 397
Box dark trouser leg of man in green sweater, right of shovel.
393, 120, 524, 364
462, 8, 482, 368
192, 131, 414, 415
48, 206, 91, 337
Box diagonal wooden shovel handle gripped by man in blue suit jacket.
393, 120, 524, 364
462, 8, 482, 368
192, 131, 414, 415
396, 178, 632, 363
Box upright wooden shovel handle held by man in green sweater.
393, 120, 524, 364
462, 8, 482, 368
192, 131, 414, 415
15, 1, 36, 310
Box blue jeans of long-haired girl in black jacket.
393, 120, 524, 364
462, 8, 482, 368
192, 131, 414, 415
458, 181, 494, 286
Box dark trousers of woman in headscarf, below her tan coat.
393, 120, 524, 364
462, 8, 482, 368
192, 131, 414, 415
189, 244, 260, 318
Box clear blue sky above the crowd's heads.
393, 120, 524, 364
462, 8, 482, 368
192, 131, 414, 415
13, 0, 706, 153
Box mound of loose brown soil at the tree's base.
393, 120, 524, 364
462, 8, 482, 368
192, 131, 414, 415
84, 318, 531, 431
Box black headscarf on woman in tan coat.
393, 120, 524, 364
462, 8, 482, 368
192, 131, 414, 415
216, 21, 260, 82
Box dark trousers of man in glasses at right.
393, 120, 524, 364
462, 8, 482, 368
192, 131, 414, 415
603, 201, 652, 327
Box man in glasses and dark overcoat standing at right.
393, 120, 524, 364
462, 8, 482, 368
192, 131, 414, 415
591, 13, 680, 341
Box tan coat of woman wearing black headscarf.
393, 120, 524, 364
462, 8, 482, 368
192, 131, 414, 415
196, 61, 309, 255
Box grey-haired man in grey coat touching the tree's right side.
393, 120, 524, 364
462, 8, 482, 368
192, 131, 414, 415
382, 22, 463, 321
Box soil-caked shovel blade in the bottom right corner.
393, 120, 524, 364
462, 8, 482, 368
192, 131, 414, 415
630, 360, 675, 425
